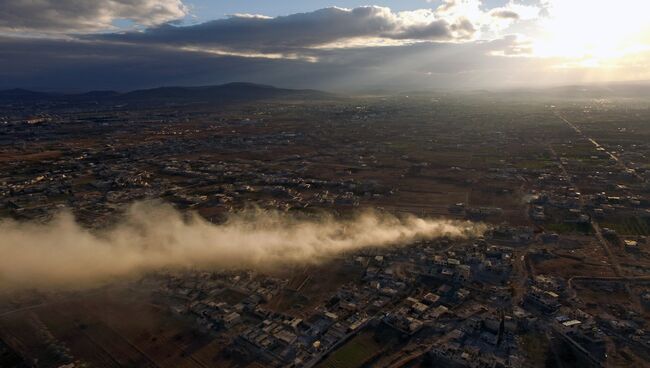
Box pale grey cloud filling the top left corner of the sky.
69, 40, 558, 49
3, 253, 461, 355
0, 0, 188, 33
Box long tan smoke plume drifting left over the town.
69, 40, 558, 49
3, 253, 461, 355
0, 202, 485, 288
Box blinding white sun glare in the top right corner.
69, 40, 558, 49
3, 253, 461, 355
533, 0, 650, 65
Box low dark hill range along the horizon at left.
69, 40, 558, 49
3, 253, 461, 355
0, 83, 333, 105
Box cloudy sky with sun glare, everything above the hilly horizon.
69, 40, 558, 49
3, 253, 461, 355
0, 0, 650, 92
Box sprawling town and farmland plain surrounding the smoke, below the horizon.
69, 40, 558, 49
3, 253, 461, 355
0, 92, 650, 368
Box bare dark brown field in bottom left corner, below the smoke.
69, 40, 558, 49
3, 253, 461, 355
0, 293, 218, 368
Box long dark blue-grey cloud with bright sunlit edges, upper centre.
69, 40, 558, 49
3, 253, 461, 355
95, 6, 475, 51
